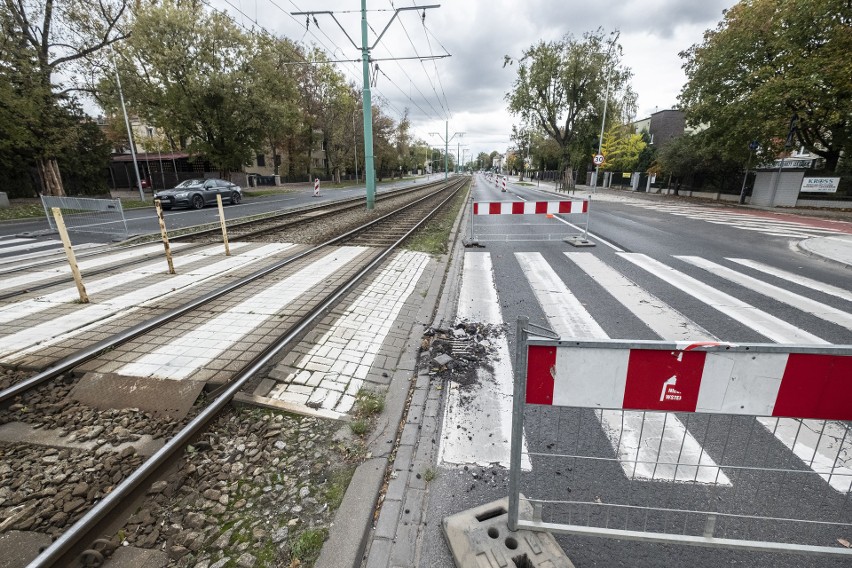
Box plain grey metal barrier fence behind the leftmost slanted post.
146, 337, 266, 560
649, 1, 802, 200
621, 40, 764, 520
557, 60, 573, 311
41, 195, 127, 238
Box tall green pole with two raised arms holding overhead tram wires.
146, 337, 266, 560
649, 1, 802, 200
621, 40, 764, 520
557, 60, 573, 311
291, 0, 441, 211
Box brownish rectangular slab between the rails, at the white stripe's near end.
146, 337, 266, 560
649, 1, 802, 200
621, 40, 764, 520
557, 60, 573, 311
71, 372, 205, 420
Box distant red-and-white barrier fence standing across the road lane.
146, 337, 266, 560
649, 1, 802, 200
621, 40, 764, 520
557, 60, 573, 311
468, 198, 591, 244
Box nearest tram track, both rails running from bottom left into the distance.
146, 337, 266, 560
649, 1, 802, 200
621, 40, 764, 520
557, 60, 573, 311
0, 175, 463, 566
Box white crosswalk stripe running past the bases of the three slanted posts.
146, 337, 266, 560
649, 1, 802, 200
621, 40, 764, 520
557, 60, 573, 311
0, 243, 255, 323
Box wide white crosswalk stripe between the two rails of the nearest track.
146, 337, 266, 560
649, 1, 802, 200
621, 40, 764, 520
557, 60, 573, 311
117, 247, 365, 380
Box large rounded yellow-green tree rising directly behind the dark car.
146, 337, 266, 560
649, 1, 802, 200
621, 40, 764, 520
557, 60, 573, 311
106, 0, 270, 179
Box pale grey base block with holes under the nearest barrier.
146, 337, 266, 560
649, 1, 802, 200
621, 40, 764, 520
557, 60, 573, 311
441, 497, 574, 568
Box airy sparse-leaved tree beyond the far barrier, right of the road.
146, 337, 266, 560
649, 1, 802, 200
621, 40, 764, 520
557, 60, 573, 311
506, 29, 636, 184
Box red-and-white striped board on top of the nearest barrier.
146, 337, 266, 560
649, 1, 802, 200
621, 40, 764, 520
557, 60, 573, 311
526, 341, 852, 420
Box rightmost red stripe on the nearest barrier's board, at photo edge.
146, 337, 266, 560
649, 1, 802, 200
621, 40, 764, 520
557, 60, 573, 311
772, 353, 852, 420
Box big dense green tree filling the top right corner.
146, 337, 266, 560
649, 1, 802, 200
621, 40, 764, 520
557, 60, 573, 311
680, 0, 852, 171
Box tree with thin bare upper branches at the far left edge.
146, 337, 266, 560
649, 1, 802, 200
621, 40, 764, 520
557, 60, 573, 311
0, 0, 129, 195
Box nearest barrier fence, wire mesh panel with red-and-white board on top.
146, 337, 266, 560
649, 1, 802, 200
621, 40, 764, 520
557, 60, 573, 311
509, 318, 852, 556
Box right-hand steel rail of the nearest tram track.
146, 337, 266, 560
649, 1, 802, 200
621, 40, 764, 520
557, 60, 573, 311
29, 175, 464, 568
